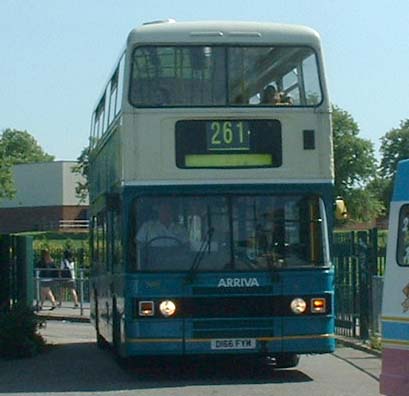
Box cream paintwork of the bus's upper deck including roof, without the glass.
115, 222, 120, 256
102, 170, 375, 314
90, 21, 334, 196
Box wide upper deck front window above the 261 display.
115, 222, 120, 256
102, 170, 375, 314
129, 46, 322, 107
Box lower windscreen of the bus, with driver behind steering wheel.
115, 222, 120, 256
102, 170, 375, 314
130, 195, 324, 271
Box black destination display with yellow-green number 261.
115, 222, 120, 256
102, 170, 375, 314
175, 120, 282, 168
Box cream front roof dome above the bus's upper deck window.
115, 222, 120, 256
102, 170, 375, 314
128, 21, 320, 47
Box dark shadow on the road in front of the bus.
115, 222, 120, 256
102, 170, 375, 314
0, 343, 312, 393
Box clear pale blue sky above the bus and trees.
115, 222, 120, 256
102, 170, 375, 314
0, 0, 409, 159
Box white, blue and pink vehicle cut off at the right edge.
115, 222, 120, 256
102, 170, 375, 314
380, 160, 409, 396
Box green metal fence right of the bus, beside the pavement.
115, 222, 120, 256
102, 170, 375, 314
333, 228, 386, 339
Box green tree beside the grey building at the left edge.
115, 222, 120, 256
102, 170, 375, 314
0, 129, 54, 199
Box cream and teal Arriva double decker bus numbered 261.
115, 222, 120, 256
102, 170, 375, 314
89, 21, 334, 367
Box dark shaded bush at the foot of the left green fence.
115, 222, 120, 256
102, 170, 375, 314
0, 303, 45, 359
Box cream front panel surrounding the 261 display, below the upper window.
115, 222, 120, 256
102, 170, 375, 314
122, 109, 333, 184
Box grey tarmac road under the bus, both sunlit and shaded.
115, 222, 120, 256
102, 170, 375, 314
0, 321, 380, 396
